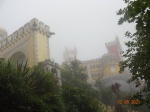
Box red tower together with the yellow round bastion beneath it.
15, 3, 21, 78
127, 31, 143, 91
101, 37, 122, 76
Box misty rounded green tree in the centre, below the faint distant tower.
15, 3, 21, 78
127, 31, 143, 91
61, 60, 105, 112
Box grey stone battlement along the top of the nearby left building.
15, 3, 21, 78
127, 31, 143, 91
0, 18, 55, 51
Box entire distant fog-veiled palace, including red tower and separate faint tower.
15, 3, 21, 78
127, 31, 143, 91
61, 37, 138, 91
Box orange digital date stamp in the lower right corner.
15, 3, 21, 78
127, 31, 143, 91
117, 100, 141, 105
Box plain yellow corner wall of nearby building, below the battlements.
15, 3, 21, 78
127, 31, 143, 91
28, 31, 49, 67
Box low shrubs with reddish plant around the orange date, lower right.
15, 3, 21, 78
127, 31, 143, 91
96, 80, 149, 112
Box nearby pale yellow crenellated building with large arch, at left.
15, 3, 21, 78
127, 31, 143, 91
0, 18, 60, 85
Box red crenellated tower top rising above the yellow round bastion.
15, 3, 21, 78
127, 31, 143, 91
105, 36, 122, 62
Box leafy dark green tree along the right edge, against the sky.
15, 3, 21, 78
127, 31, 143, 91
117, 0, 150, 107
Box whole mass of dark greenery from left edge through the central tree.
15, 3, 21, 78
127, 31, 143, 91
0, 59, 106, 112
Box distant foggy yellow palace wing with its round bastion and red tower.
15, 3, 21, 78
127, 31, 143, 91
82, 37, 122, 83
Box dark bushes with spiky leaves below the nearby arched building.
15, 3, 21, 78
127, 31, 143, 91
0, 60, 64, 112
